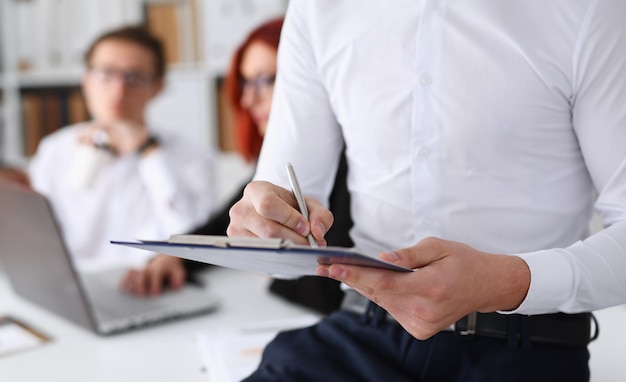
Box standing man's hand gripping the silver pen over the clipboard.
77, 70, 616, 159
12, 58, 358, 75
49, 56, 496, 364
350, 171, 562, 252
227, 181, 334, 246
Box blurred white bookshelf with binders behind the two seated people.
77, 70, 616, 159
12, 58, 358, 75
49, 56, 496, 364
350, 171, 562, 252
0, 0, 288, 167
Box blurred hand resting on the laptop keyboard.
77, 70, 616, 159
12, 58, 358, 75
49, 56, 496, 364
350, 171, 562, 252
120, 255, 187, 296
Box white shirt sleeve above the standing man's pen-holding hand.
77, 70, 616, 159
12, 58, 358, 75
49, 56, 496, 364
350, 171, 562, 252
254, 0, 343, 205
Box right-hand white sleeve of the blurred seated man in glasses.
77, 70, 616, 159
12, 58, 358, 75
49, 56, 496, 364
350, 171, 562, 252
139, 137, 216, 233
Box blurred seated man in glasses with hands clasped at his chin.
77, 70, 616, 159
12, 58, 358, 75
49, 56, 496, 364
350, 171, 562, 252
29, 26, 214, 264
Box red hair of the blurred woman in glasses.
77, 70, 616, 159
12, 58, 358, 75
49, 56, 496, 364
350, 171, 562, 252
225, 17, 283, 162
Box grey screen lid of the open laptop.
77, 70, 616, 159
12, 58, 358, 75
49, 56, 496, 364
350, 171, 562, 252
0, 181, 95, 330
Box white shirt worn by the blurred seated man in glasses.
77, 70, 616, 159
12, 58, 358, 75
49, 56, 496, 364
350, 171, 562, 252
29, 125, 215, 264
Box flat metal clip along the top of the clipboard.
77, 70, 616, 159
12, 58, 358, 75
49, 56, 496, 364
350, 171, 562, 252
168, 234, 293, 249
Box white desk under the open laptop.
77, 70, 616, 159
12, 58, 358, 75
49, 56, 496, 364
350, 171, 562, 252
0, 269, 626, 382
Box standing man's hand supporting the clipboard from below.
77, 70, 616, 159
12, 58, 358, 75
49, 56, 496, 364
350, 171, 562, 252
317, 238, 530, 339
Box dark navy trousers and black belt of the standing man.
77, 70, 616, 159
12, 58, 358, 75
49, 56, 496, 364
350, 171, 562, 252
245, 308, 589, 382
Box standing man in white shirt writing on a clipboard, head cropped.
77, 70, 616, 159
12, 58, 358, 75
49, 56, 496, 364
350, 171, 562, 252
228, 0, 626, 381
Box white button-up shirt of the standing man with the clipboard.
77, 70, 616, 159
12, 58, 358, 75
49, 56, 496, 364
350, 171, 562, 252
255, 0, 626, 314
